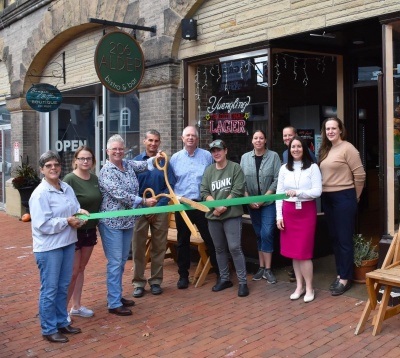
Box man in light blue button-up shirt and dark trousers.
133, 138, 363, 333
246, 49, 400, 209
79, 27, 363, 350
170, 126, 219, 289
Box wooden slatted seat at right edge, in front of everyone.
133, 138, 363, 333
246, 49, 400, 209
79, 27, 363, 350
354, 233, 400, 336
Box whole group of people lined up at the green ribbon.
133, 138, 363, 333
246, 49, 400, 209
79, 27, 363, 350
29, 118, 365, 342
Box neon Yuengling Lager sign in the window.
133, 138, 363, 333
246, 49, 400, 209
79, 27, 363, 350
206, 96, 251, 134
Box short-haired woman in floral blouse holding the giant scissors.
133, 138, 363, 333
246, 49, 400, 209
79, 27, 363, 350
99, 134, 163, 316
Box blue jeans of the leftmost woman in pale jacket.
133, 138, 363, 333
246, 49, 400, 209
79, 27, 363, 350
34, 244, 75, 335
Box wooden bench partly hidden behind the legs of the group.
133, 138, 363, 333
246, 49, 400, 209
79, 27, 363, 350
146, 213, 212, 287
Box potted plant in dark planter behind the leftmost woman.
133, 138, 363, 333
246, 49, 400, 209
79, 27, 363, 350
11, 156, 40, 213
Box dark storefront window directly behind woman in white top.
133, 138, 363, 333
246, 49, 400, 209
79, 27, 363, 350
271, 49, 337, 156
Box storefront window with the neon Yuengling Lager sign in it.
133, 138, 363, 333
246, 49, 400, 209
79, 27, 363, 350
194, 50, 269, 162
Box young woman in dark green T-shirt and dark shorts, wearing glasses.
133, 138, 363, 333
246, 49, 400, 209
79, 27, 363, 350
63, 145, 102, 317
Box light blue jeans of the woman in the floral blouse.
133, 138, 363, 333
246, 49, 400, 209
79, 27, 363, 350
99, 224, 133, 309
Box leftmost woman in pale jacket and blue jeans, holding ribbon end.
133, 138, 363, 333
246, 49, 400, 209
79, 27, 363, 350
29, 151, 89, 343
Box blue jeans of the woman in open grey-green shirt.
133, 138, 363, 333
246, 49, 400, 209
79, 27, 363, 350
248, 204, 276, 252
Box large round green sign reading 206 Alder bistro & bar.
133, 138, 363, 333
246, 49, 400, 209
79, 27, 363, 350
94, 31, 144, 94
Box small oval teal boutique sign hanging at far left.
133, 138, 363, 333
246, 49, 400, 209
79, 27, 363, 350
26, 83, 62, 112
